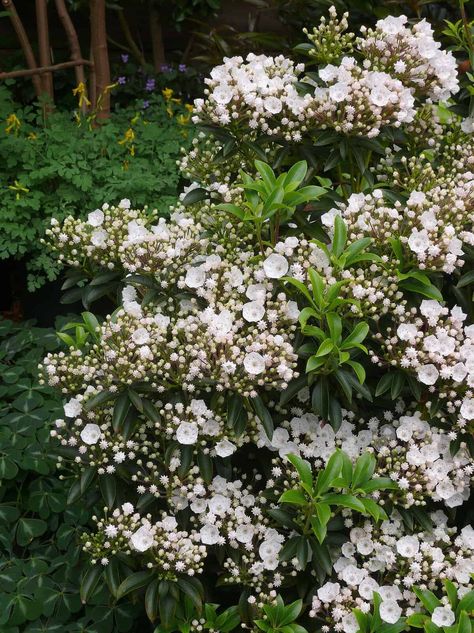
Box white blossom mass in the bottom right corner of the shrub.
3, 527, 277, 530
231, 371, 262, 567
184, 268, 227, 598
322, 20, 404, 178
310, 512, 474, 633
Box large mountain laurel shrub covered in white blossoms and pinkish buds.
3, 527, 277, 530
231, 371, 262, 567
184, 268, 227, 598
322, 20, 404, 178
41, 9, 474, 633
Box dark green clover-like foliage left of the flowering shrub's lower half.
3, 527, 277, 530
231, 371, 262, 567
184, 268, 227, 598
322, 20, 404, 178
0, 321, 148, 633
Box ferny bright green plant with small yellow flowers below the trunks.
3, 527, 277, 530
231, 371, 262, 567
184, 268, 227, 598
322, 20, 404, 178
0, 88, 193, 290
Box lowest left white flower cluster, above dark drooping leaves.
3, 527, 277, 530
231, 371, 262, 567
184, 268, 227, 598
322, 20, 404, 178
82, 502, 207, 580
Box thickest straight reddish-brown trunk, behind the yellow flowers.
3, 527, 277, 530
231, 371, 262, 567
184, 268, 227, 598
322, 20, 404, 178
90, 0, 110, 119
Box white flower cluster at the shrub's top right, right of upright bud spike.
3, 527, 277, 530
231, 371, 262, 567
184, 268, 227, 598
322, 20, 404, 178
356, 15, 459, 101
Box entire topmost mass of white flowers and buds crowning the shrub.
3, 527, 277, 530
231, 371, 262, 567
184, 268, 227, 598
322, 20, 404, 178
194, 8, 458, 142
